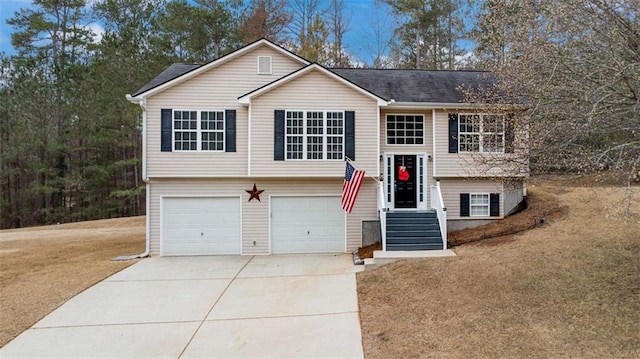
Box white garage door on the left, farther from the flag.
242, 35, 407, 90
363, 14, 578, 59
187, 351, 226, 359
162, 197, 240, 256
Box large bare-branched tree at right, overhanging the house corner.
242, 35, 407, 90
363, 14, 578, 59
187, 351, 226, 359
469, 0, 640, 183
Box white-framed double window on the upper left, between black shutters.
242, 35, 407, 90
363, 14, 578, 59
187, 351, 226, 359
173, 110, 224, 152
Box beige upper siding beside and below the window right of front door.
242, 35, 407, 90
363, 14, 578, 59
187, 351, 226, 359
434, 109, 526, 178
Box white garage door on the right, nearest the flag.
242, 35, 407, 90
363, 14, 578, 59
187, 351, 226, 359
271, 197, 346, 253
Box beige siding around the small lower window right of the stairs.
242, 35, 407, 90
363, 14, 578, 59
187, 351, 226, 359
440, 178, 504, 220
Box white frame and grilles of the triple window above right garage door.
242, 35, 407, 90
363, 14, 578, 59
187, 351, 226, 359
284, 109, 347, 161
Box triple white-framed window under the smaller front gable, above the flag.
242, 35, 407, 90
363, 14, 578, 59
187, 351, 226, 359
285, 111, 344, 160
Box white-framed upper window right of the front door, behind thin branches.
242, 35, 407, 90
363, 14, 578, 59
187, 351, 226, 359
458, 114, 504, 152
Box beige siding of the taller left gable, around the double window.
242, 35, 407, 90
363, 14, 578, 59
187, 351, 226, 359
146, 46, 302, 177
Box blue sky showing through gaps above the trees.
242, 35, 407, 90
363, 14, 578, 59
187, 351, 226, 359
0, 0, 400, 63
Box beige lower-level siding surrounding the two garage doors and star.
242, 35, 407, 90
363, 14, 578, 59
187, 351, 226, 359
148, 178, 377, 255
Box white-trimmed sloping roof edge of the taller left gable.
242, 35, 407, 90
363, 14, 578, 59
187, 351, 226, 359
132, 39, 309, 99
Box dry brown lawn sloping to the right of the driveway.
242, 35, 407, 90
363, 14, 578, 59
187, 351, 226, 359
358, 186, 640, 358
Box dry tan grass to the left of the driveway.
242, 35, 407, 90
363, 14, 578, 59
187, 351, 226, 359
0, 217, 145, 347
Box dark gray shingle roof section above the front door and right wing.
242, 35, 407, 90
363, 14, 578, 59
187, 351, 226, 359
330, 69, 491, 103
